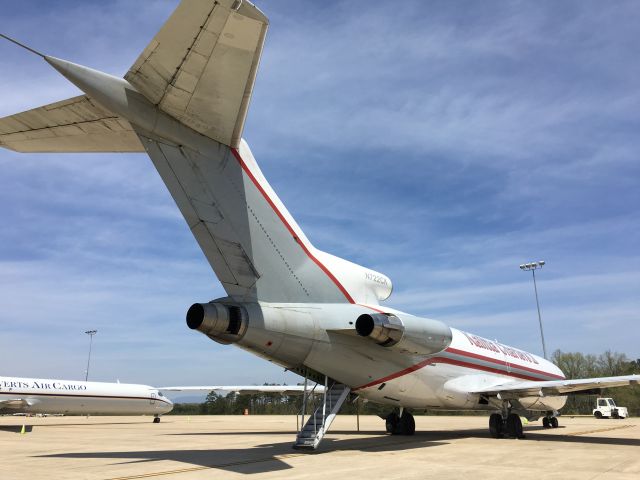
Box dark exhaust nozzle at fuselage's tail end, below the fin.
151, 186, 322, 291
187, 302, 249, 344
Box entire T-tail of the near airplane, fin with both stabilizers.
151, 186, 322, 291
0, 0, 392, 305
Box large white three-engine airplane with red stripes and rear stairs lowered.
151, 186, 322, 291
0, 0, 640, 448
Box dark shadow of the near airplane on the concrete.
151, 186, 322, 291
36, 428, 640, 474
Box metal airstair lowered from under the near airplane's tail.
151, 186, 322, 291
293, 377, 351, 450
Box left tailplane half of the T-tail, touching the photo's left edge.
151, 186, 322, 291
0, 95, 144, 152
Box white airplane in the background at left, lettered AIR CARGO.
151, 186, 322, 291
0, 377, 173, 423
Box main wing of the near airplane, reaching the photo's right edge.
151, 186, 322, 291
471, 375, 640, 398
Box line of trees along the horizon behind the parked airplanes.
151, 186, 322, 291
171, 350, 640, 416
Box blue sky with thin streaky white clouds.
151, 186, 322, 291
0, 0, 640, 385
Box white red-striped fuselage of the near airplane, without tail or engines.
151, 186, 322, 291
192, 299, 565, 411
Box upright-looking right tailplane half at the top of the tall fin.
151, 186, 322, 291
125, 0, 269, 148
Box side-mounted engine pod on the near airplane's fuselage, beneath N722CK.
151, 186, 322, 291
356, 313, 452, 355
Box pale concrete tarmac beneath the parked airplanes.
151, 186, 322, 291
0, 416, 640, 480
